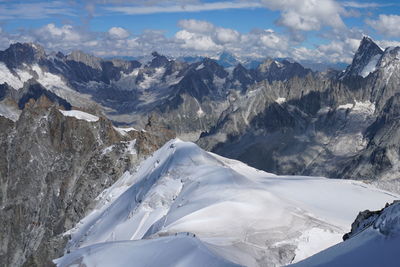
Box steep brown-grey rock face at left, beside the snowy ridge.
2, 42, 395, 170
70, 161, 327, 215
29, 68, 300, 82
0, 97, 168, 266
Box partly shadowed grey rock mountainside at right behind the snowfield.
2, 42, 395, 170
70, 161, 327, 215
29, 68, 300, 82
198, 38, 400, 191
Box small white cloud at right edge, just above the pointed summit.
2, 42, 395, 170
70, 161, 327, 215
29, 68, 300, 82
366, 14, 400, 37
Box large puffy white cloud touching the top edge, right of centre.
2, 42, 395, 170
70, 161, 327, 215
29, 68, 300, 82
262, 0, 345, 31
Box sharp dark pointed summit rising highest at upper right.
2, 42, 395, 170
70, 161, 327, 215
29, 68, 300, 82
342, 36, 383, 78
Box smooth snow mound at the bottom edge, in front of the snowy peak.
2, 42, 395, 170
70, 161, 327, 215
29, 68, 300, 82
56, 233, 239, 267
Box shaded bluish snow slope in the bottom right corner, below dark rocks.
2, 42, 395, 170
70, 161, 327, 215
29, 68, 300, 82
291, 203, 400, 267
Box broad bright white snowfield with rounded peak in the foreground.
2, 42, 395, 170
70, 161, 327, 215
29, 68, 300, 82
55, 140, 397, 267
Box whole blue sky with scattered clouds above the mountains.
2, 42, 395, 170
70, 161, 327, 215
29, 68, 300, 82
0, 0, 400, 63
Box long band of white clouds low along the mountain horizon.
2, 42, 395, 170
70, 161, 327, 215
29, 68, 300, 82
0, 16, 399, 66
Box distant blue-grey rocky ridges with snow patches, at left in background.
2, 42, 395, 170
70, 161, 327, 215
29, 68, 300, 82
0, 44, 318, 140
